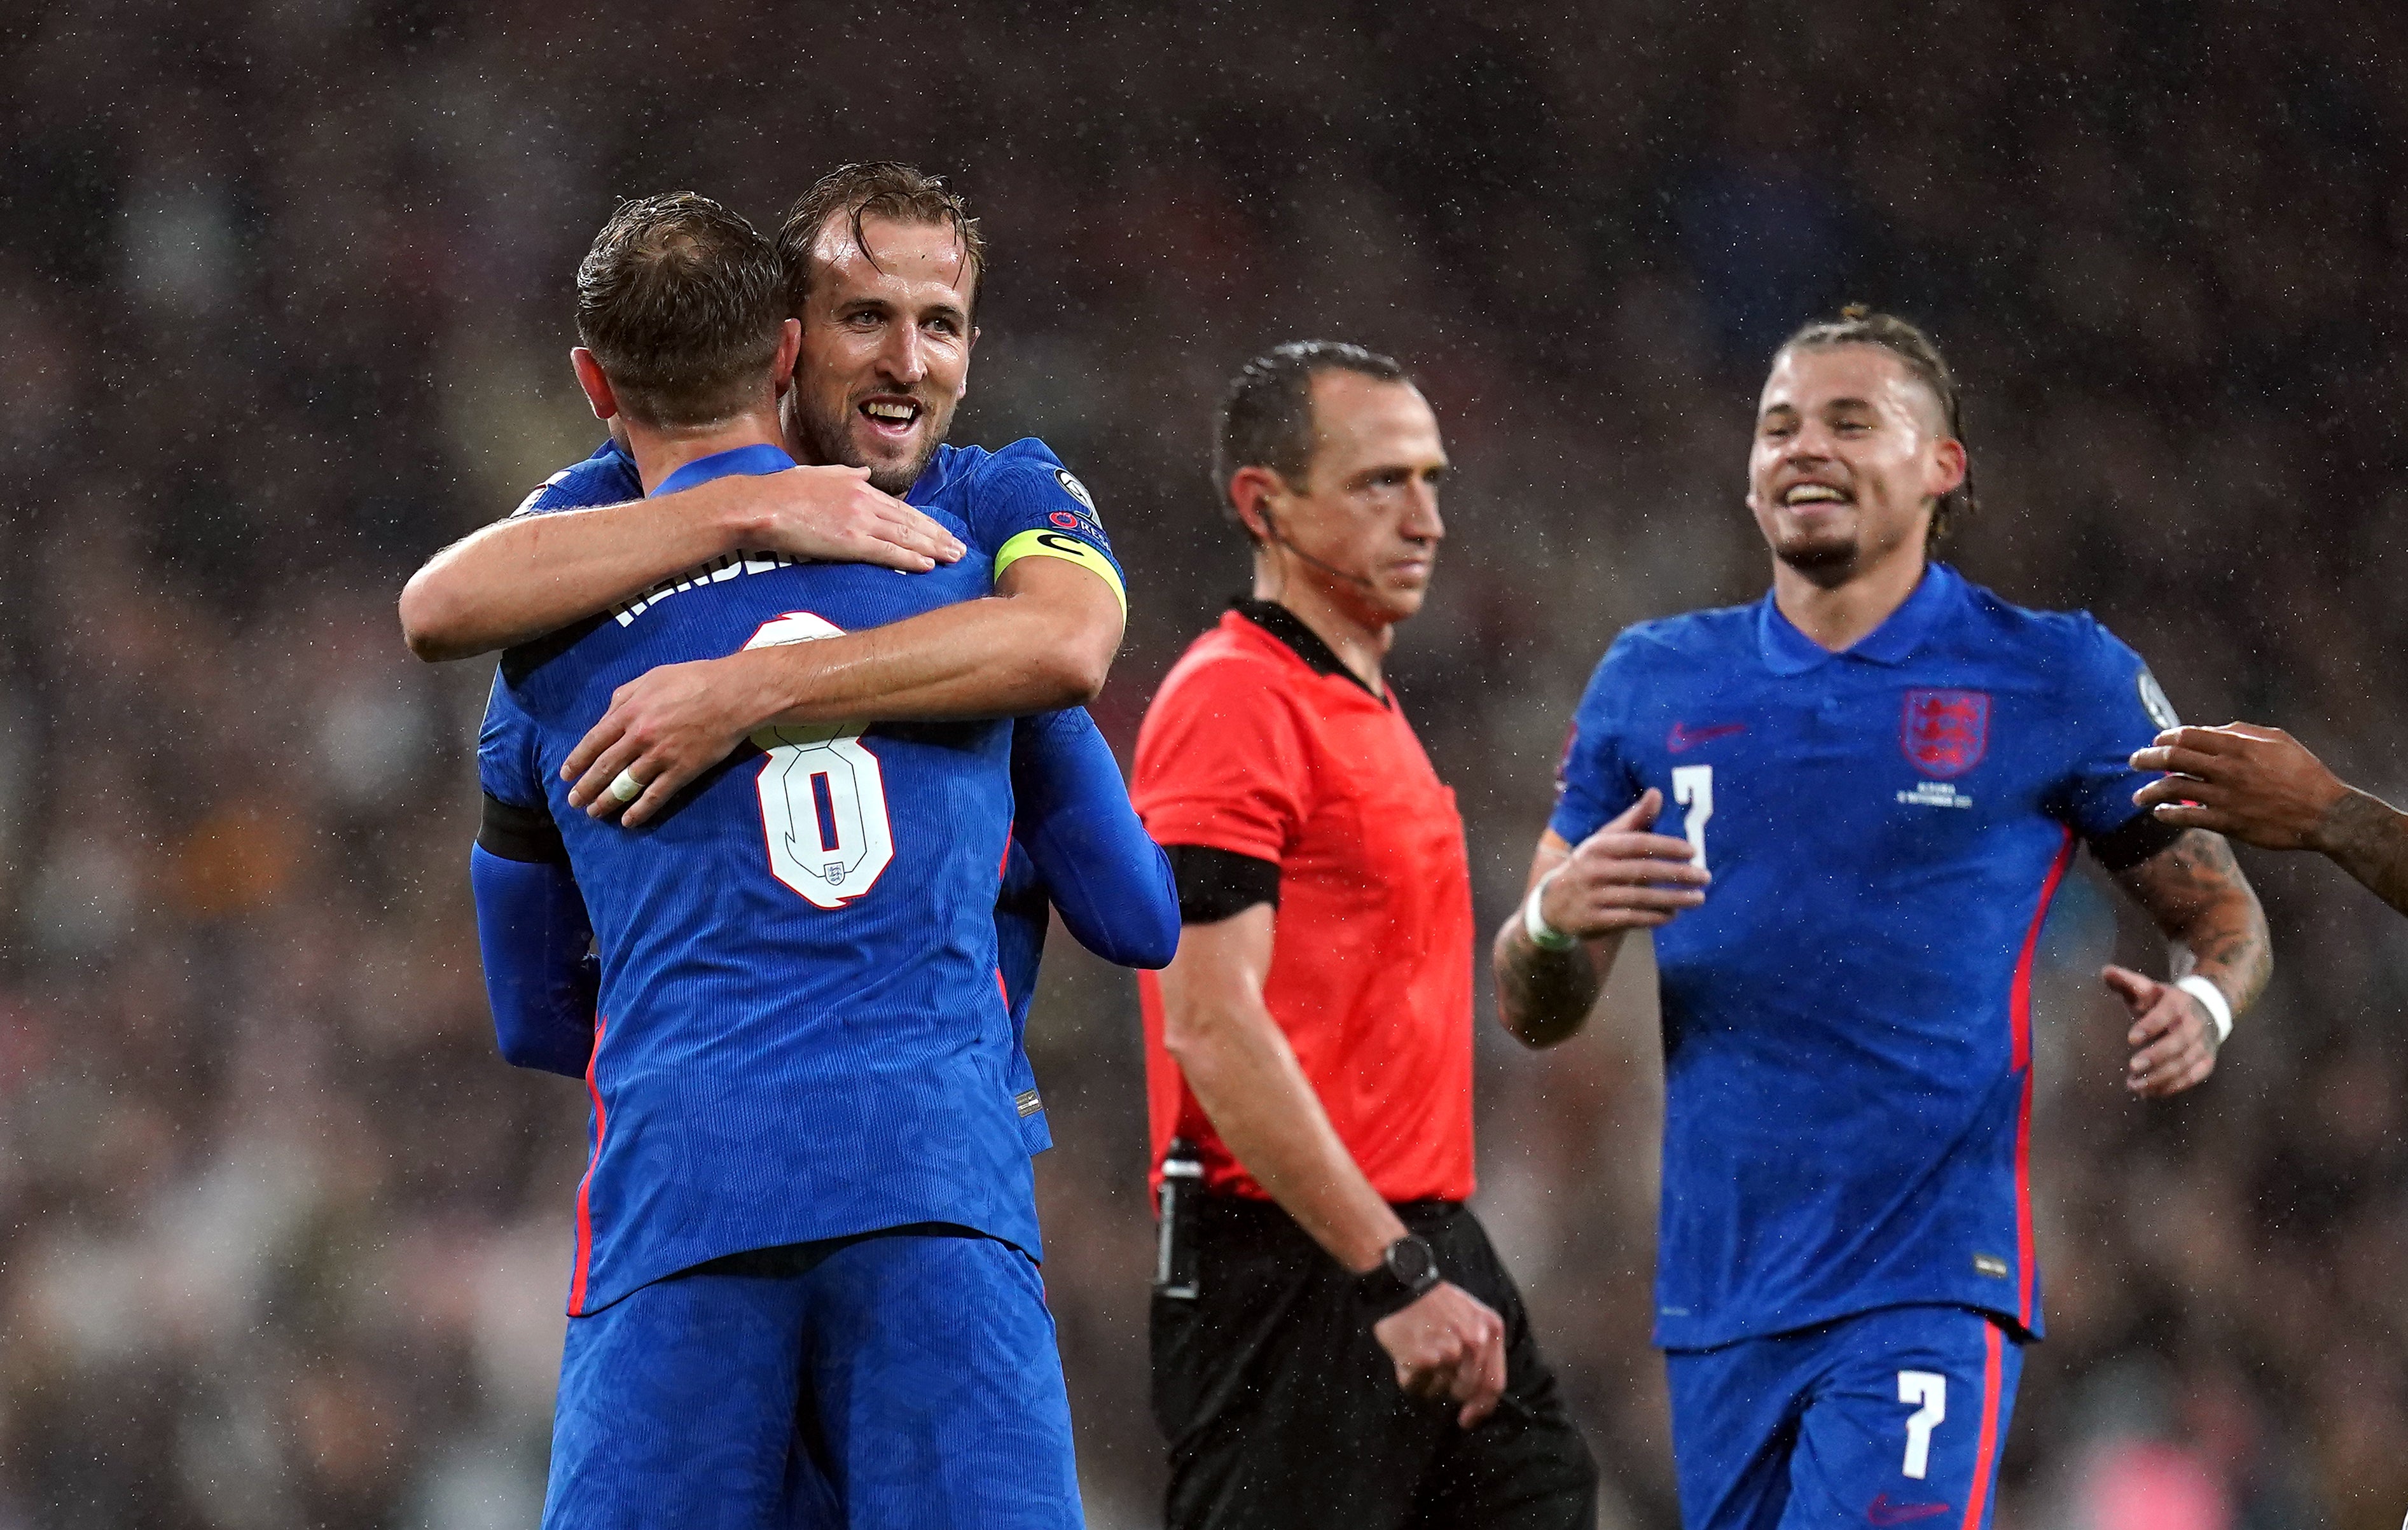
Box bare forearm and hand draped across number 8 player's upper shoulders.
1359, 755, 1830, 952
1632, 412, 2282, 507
402, 468, 963, 660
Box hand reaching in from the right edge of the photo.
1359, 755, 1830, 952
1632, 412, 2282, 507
2131, 723, 2350, 851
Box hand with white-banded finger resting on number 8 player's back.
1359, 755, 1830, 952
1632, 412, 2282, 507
561, 648, 778, 829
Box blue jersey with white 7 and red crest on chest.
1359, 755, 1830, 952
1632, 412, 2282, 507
1551, 564, 2172, 1349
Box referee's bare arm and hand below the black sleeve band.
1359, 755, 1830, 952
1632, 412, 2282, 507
1161, 903, 1505, 1429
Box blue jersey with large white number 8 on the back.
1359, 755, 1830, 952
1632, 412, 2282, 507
479, 443, 1100, 1313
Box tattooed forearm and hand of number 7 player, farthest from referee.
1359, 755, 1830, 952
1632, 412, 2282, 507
2100, 829, 2273, 1099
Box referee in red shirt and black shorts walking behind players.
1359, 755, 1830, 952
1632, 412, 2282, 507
1131, 342, 1596, 1530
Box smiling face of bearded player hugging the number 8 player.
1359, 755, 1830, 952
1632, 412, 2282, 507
785, 217, 978, 494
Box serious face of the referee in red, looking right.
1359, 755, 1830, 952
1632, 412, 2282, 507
1231, 368, 1447, 627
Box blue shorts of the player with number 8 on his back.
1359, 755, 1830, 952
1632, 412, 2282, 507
544, 1227, 1081, 1530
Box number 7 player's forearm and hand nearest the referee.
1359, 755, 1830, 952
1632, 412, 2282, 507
1491, 788, 1712, 1046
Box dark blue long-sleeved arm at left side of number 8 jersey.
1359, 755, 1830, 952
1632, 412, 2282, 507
469, 798, 602, 1077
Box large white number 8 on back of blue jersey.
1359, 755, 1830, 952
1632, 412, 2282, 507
744, 612, 896, 908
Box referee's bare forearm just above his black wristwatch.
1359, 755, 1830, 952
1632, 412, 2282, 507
1173, 998, 1406, 1272
